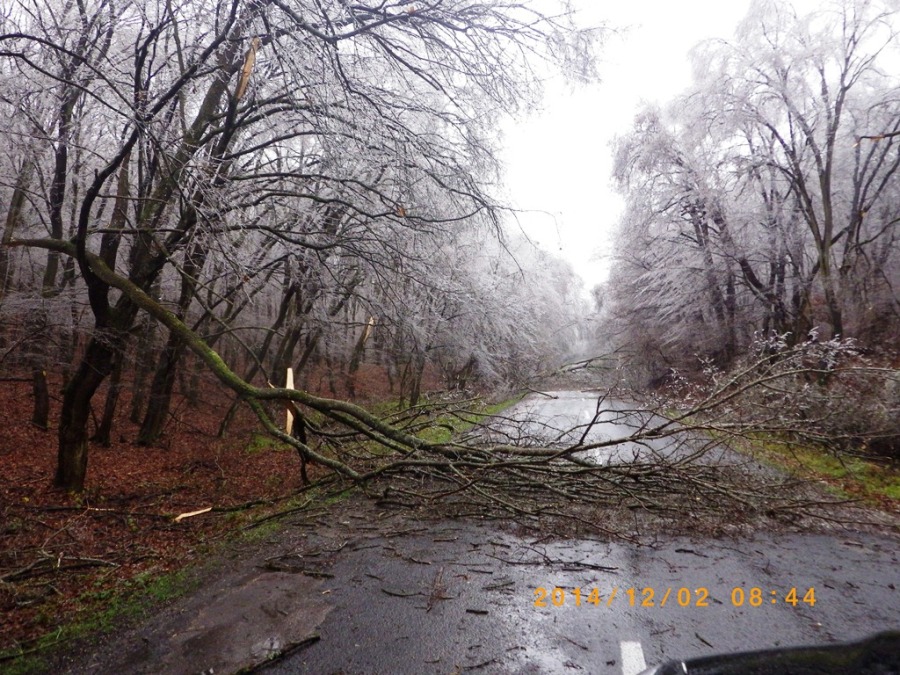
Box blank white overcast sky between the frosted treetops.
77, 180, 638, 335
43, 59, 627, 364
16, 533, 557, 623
503, 0, 750, 288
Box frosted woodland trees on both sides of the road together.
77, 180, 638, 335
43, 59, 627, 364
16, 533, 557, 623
0, 0, 900, 491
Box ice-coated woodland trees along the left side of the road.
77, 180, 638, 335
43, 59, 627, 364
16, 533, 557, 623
0, 0, 595, 490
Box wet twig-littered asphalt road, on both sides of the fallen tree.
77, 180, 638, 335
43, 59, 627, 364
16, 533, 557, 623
59, 392, 900, 675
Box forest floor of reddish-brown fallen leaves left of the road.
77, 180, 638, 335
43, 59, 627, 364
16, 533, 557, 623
0, 364, 432, 672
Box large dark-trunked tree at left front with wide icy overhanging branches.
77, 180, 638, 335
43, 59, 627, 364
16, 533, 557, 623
0, 0, 604, 490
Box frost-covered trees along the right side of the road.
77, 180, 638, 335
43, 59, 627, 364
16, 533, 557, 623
598, 0, 900, 384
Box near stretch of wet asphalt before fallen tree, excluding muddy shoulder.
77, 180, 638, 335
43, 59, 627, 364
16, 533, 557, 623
264, 523, 900, 675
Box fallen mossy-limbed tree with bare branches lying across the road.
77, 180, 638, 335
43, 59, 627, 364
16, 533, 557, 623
16, 240, 888, 535
